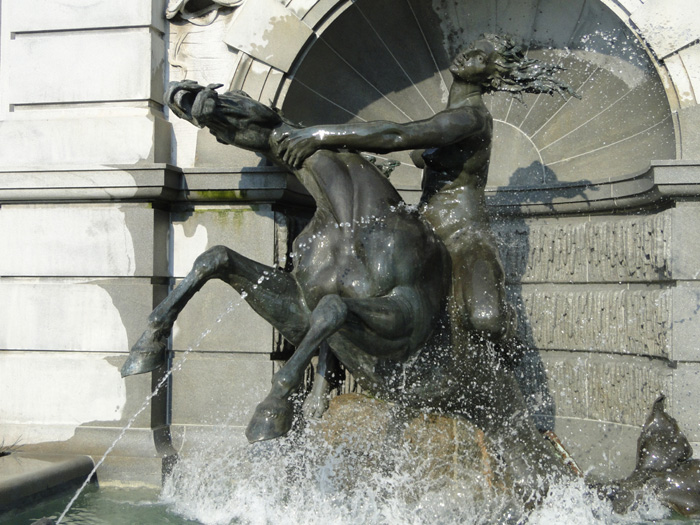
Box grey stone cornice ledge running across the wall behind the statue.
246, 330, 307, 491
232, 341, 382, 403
0, 161, 700, 215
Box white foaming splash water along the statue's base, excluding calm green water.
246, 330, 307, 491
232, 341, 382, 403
161, 420, 670, 525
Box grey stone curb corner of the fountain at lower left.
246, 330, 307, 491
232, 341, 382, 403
0, 452, 94, 512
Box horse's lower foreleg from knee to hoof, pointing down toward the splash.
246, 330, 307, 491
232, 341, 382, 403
245, 295, 348, 443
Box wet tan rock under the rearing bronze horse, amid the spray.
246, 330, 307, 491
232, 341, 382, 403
308, 394, 513, 499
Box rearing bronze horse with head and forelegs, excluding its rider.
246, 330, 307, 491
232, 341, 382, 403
122, 81, 563, 488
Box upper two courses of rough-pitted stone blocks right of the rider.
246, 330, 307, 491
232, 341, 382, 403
494, 210, 673, 358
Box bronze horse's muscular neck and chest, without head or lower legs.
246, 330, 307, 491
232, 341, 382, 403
292, 151, 449, 364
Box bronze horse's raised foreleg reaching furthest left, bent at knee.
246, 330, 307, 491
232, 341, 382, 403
122, 246, 308, 377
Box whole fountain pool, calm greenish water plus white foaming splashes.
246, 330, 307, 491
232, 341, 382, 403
9, 427, 700, 525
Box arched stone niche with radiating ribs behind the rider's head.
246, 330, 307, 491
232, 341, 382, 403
212, 0, 679, 192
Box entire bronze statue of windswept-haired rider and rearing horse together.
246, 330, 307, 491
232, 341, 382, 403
122, 36, 700, 512
